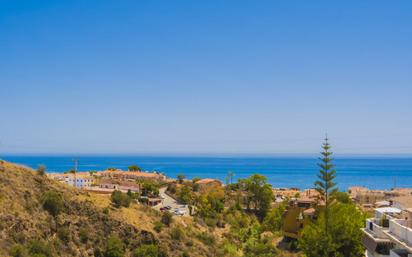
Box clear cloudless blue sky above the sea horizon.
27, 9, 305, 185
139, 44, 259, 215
0, 0, 412, 154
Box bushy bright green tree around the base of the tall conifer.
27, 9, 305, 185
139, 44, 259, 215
298, 202, 366, 257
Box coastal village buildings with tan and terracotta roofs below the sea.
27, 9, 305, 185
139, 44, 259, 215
47, 165, 412, 257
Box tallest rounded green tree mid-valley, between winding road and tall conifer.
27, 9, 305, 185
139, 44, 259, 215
239, 174, 273, 216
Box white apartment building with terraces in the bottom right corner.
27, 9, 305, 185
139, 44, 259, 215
362, 204, 412, 257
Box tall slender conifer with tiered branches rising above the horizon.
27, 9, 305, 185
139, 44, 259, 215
315, 136, 337, 234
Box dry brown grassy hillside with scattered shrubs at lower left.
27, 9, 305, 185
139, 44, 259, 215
0, 161, 216, 257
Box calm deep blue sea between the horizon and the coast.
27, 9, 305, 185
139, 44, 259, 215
2, 156, 412, 190
